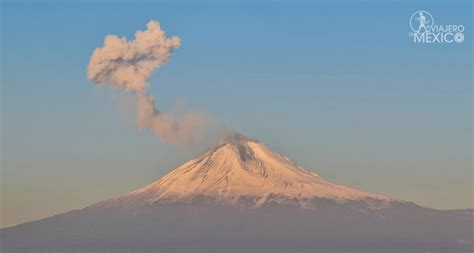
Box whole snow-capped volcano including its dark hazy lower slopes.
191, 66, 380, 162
1, 134, 474, 252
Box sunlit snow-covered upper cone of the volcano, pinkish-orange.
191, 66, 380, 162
99, 134, 393, 208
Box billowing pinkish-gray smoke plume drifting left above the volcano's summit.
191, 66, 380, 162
87, 20, 209, 144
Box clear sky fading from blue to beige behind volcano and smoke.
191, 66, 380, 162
0, 0, 473, 227
